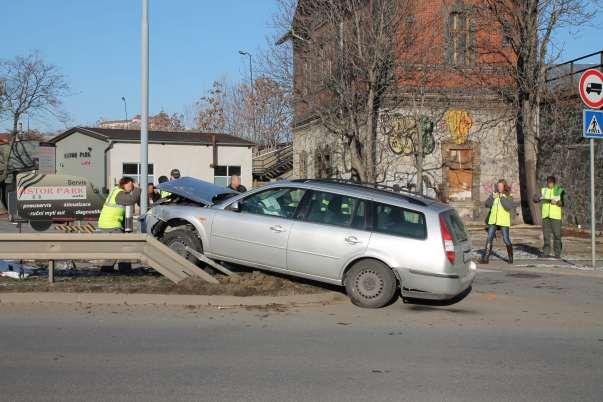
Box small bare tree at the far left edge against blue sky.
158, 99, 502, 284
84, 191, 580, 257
0, 53, 69, 182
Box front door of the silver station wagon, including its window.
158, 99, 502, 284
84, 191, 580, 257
211, 188, 305, 269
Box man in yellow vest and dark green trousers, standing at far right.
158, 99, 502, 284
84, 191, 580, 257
534, 176, 565, 258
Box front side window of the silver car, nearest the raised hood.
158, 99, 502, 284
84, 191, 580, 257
239, 188, 305, 219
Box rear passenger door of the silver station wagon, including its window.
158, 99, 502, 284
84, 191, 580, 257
287, 191, 371, 279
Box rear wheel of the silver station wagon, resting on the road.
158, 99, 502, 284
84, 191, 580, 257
344, 260, 397, 308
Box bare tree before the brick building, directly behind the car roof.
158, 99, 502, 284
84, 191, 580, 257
293, 0, 411, 182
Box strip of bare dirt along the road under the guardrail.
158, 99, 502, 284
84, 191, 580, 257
0, 269, 331, 296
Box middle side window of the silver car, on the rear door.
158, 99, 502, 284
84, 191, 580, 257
304, 191, 367, 229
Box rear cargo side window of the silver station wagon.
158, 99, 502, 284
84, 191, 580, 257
373, 203, 427, 239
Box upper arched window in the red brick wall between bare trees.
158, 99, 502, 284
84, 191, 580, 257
447, 9, 475, 66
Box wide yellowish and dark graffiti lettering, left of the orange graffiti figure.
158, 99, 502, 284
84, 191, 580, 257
381, 114, 435, 155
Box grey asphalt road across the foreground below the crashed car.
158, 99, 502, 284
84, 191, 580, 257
0, 271, 603, 401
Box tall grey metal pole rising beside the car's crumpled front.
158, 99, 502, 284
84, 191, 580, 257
140, 0, 149, 217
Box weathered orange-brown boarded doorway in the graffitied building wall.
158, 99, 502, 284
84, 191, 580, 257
448, 148, 474, 201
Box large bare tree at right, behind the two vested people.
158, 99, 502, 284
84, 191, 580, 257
480, 0, 596, 223
